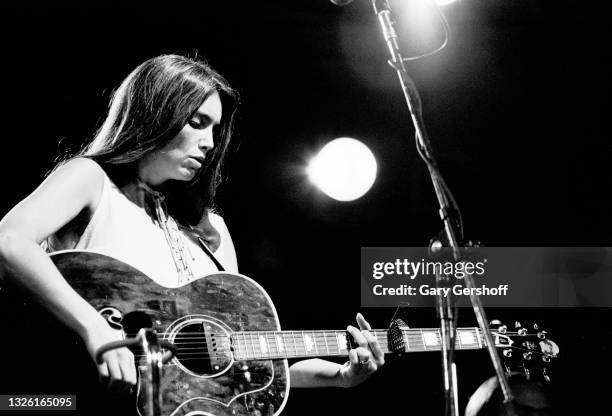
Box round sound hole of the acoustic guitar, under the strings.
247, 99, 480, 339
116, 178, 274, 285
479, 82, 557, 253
173, 320, 232, 377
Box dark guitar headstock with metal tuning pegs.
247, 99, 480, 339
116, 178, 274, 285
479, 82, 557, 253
490, 320, 559, 381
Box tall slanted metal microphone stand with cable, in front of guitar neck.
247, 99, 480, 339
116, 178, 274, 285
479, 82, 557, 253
372, 0, 516, 416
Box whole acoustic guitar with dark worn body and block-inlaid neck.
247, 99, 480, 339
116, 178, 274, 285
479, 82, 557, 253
0, 250, 558, 416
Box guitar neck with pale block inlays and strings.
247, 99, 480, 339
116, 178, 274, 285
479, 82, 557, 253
232, 328, 485, 360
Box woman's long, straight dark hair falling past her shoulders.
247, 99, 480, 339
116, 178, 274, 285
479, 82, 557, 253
77, 55, 238, 226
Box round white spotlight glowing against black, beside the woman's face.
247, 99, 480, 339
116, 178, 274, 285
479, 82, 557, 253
306, 137, 376, 201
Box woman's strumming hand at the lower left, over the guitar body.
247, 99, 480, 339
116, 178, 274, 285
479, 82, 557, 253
83, 317, 137, 392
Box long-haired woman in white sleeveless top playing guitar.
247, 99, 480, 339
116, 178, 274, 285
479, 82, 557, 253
0, 55, 384, 410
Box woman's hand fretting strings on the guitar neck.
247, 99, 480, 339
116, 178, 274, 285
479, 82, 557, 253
338, 313, 385, 387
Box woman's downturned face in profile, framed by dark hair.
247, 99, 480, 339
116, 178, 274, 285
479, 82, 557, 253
138, 92, 222, 185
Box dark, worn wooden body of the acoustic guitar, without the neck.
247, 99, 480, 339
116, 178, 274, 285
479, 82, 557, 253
51, 250, 289, 416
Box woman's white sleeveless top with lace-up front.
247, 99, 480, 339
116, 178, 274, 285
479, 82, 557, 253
47, 169, 238, 287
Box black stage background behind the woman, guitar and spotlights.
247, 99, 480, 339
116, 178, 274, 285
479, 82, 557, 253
0, 0, 612, 415
